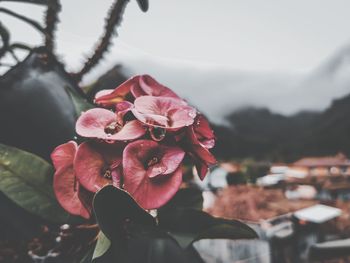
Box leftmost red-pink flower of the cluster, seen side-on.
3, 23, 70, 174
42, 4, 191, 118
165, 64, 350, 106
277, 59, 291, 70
51, 141, 92, 219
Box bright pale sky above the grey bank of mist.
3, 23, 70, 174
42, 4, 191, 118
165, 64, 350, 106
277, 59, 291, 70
0, 0, 350, 71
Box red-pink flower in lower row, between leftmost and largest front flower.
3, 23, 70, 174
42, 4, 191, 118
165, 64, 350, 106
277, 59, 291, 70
74, 142, 123, 192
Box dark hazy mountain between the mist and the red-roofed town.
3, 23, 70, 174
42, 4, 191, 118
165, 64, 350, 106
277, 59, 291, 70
214, 95, 350, 162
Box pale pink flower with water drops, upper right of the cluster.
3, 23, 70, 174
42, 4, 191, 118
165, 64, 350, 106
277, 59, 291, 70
132, 96, 196, 130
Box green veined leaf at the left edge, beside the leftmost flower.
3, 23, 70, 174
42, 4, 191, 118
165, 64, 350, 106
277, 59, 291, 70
0, 144, 69, 223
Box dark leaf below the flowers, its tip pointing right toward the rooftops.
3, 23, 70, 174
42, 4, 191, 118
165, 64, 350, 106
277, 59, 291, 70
158, 208, 257, 248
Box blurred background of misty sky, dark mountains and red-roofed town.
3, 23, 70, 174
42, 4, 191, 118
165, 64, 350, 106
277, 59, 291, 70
0, 0, 350, 262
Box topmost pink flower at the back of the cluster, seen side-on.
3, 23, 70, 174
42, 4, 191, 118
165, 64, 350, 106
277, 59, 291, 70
95, 75, 179, 107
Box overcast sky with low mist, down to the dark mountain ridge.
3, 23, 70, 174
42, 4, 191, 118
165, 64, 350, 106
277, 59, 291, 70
0, 0, 350, 123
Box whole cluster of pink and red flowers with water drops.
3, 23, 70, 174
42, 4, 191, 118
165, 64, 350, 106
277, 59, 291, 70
51, 75, 216, 218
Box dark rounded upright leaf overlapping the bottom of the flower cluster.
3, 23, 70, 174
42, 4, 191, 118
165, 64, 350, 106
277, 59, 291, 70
93, 185, 156, 239
